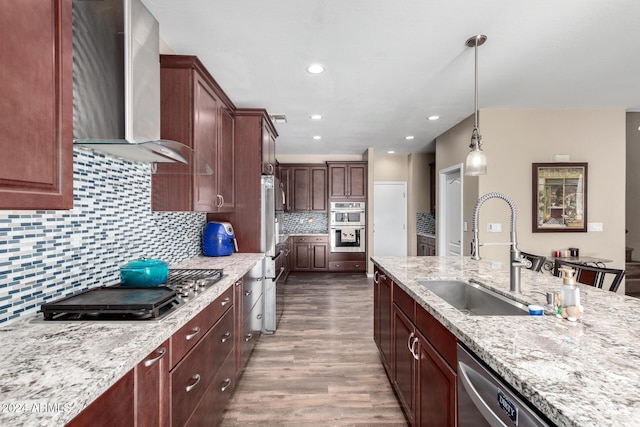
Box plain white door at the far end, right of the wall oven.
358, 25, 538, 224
373, 182, 407, 256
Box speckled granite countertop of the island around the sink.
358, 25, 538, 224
371, 257, 640, 427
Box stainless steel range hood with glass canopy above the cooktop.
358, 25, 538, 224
73, 0, 213, 174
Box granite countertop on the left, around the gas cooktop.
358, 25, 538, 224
0, 253, 264, 426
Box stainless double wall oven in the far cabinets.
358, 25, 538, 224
329, 202, 366, 252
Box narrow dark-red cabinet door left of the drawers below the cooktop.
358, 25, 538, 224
135, 341, 169, 427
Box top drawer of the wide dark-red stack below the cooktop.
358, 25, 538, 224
171, 287, 233, 368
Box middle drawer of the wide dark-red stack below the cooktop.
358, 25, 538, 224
170, 310, 233, 426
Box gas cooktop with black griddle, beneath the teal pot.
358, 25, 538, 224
40, 269, 223, 320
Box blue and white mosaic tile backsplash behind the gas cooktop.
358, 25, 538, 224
0, 149, 206, 325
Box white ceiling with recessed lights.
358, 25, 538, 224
143, 0, 640, 154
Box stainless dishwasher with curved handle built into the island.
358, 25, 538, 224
458, 344, 553, 427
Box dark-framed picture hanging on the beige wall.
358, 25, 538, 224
532, 162, 588, 233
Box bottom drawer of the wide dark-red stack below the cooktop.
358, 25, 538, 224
186, 350, 236, 427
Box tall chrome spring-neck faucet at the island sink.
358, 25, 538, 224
471, 193, 531, 294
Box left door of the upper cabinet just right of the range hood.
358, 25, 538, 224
193, 73, 220, 212
